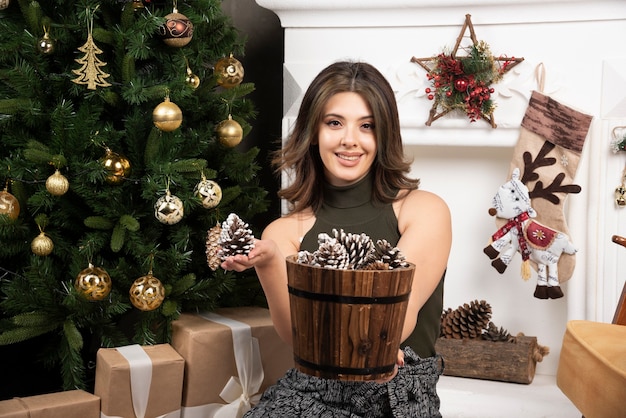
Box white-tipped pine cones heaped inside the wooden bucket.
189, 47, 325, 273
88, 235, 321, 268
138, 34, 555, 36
298, 229, 409, 270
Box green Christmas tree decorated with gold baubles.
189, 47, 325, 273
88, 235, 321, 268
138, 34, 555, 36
0, 0, 268, 389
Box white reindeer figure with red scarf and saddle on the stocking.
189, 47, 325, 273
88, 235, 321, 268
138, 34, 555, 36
483, 168, 576, 299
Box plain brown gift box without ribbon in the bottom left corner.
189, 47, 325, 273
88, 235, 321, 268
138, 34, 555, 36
0, 390, 100, 418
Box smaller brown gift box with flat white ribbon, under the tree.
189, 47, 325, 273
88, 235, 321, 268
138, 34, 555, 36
94, 344, 185, 418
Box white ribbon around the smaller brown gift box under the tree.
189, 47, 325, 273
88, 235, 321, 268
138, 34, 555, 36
100, 344, 180, 418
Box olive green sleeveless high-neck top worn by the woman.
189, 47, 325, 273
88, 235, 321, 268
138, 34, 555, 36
300, 174, 445, 358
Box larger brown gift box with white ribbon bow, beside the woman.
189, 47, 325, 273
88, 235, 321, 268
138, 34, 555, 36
172, 307, 294, 418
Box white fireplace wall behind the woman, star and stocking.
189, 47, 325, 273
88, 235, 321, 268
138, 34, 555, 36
257, 0, 626, 375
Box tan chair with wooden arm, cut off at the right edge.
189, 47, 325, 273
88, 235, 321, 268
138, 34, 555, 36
556, 235, 626, 418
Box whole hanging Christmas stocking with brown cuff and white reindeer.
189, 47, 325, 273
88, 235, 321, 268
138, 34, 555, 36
484, 91, 592, 299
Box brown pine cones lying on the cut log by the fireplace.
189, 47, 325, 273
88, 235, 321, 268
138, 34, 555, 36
440, 300, 516, 342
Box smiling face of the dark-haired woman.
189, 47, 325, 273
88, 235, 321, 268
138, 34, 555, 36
318, 92, 376, 186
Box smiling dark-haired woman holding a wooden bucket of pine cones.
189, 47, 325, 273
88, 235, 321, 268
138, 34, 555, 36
222, 62, 452, 418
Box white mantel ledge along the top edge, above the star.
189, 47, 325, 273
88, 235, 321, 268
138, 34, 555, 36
257, 0, 626, 28
